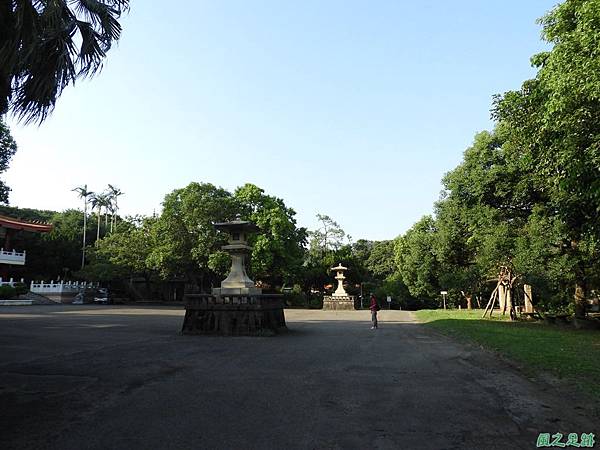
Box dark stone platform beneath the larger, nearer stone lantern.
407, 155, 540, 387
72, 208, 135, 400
181, 294, 287, 336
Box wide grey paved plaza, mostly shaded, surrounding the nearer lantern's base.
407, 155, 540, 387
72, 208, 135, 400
0, 305, 598, 450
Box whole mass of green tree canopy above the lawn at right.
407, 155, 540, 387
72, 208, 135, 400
386, 0, 600, 315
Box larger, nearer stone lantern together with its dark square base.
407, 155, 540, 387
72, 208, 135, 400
181, 219, 286, 336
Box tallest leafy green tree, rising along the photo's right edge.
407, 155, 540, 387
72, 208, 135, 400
494, 0, 600, 316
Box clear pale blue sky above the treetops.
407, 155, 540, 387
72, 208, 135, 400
5, 0, 556, 240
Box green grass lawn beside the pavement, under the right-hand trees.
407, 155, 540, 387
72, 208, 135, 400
415, 310, 600, 399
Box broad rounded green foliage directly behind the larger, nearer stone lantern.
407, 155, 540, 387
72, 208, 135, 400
142, 183, 306, 290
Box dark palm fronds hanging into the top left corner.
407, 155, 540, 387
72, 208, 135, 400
0, 0, 129, 123
